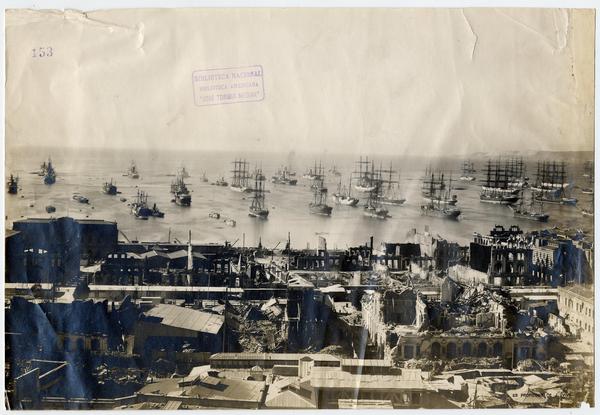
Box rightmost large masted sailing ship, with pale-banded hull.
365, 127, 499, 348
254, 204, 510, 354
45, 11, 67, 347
532, 161, 577, 206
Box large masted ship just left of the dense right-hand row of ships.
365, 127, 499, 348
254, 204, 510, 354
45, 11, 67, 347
421, 169, 461, 220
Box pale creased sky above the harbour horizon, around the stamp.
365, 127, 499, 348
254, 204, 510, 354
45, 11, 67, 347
6, 9, 594, 156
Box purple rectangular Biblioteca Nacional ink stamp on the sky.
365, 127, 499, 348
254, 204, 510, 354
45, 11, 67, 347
192, 65, 265, 106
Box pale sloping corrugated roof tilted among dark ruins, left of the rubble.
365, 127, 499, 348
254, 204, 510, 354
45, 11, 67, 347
145, 304, 225, 334
